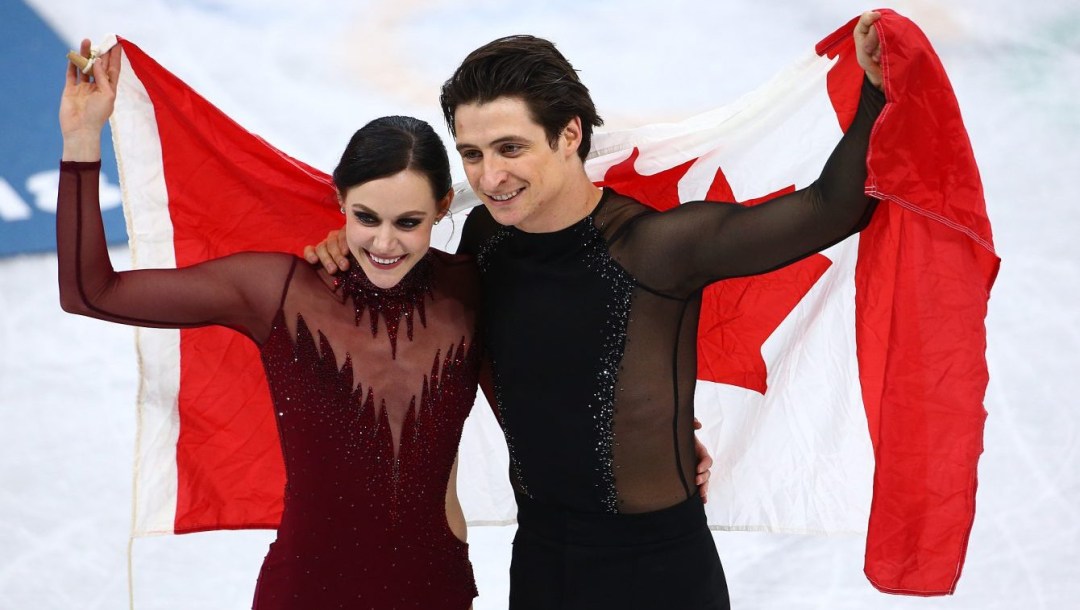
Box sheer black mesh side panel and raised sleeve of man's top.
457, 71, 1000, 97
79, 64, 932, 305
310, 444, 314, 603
594, 78, 883, 513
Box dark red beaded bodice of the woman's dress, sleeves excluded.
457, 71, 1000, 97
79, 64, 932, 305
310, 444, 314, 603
259, 249, 480, 607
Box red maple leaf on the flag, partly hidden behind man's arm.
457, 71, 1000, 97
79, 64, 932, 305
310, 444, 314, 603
597, 148, 832, 394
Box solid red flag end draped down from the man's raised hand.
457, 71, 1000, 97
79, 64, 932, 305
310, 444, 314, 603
855, 14, 1000, 595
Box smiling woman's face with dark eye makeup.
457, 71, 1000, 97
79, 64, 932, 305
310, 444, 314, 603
342, 170, 453, 288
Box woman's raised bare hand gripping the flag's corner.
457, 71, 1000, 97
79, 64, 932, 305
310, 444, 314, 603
59, 40, 120, 161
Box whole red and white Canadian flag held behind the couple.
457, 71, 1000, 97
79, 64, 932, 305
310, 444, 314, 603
111, 11, 999, 595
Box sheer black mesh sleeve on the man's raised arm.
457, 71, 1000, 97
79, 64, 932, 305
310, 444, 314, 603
612, 79, 885, 296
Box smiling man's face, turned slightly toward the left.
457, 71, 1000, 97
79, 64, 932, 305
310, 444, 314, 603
454, 97, 581, 233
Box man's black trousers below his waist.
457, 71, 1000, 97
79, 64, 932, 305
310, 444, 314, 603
510, 496, 730, 610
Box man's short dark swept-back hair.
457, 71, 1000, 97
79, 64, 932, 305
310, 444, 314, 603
440, 35, 604, 161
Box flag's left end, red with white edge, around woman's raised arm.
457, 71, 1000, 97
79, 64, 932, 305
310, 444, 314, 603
111, 39, 341, 536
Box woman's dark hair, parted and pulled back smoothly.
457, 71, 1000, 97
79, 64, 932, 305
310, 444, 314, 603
334, 117, 451, 201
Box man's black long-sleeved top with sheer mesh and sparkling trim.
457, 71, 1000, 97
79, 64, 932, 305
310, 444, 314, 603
459, 76, 885, 513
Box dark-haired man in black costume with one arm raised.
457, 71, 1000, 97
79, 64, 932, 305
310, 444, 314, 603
309, 12, 885, 610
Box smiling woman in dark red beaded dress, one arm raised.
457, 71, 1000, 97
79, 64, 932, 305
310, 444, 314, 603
57, 41, 480, 610
